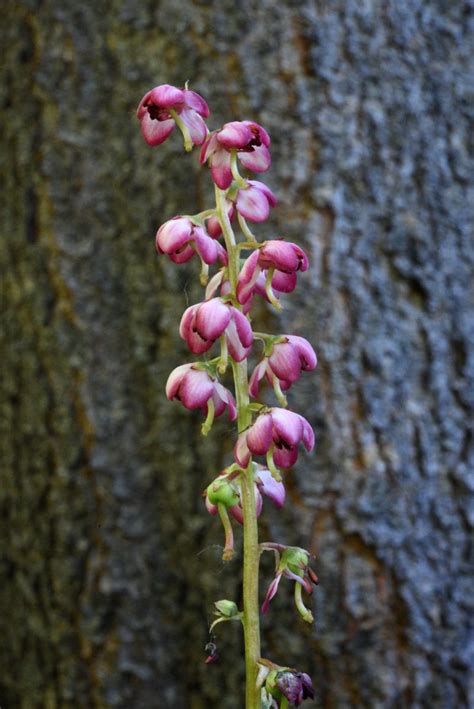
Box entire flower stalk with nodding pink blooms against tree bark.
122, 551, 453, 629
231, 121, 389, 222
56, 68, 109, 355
137, 84, 318, 709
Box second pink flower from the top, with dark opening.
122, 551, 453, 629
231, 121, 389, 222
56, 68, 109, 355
200, 121, 271, 190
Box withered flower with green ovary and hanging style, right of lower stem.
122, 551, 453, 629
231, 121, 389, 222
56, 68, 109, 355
261, 542, 319, 623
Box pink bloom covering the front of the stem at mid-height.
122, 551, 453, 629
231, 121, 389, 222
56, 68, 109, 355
179, 298, 253, 362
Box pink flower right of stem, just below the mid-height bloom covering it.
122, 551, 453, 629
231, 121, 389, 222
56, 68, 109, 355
249, 335, 317, 397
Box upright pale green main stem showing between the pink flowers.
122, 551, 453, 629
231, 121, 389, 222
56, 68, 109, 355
216, 187, 260, 709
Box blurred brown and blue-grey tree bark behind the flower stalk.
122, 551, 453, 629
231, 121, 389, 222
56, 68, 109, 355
0, 0, 474, 709
